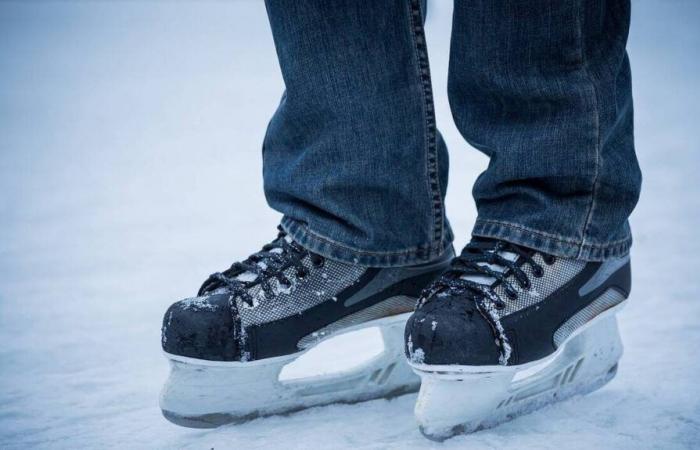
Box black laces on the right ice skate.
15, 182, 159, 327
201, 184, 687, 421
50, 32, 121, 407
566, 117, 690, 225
419, 240, 555, 309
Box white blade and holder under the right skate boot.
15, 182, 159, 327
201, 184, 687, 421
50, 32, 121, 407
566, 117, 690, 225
411, 302, 624, 441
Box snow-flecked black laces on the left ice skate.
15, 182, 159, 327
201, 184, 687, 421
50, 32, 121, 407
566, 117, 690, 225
197, 226, 325, 306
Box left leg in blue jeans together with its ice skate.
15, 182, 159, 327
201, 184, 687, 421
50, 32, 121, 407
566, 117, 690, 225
160, 0, 454, 427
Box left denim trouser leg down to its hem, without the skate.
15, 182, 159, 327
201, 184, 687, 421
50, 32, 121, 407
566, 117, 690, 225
263, 0, 452, 266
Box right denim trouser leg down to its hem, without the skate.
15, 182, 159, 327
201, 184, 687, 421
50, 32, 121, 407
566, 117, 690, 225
448, 0, 641, 260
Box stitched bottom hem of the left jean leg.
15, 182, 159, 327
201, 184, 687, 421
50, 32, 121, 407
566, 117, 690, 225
281, 216, 454, 267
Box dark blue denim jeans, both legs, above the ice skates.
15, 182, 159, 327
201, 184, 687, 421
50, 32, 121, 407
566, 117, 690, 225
263, 0, 641, 266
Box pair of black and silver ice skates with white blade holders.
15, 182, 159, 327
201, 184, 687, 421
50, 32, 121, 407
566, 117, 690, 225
161, 231, 630, 440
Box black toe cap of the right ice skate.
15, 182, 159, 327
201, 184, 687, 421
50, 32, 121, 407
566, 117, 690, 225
405, 297, 500, 365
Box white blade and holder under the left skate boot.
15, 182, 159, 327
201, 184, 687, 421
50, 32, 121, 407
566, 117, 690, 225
160, 313, 420, 428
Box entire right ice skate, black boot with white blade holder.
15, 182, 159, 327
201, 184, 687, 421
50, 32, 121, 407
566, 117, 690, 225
405, 238, 630, 440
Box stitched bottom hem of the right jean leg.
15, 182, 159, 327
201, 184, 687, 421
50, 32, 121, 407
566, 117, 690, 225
472, 218, 632, 261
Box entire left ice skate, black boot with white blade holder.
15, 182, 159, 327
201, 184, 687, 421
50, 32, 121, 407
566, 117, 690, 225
160, 230, 454, 428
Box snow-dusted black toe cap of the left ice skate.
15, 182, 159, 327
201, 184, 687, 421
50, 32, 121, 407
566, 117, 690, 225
161, 294, 238, 361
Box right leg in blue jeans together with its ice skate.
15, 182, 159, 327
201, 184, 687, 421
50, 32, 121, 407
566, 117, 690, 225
405, 0, 641, 439
